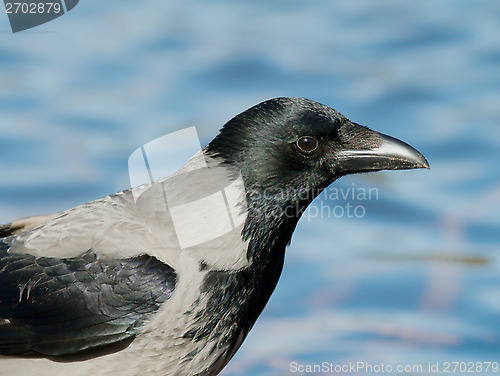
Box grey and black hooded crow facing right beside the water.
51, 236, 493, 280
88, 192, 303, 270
0, 98, 429, 376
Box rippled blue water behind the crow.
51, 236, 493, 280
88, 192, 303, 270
0, 0, 500, 376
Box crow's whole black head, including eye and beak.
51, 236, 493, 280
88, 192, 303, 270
207, 98, 429, 209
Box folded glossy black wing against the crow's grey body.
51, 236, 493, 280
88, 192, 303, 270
0, 238, 176, 355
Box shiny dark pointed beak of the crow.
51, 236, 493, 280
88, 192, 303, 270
337, 133, 430, 174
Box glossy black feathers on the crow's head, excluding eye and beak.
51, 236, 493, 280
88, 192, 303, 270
207, 98, 378, 196
